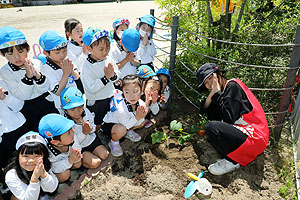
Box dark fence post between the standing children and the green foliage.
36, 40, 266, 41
168, 16, 179, 117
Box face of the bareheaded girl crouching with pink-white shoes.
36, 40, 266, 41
123, 83, 142, 105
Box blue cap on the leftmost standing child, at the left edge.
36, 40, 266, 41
0, 26, 27, 49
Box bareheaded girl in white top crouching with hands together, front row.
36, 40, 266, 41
101, 75, 147, 157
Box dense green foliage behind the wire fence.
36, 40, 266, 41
155, 0, 300, 125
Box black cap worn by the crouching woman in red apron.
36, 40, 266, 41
196, 63, 227, 88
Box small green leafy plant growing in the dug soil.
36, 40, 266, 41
151, 120, 194, 146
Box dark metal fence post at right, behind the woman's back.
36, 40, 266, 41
271, 25, 300, 145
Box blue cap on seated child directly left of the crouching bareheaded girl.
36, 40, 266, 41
60, 87, 85, 110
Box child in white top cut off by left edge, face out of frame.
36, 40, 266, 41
0, 80, 28, 177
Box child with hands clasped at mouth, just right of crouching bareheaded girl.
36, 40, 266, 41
143, 76, 162, 128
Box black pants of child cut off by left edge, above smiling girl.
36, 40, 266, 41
0, 123, 29, 169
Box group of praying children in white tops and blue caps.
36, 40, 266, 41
0, 15, 170, 199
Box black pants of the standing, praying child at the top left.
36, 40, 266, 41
20, 92, 58, 132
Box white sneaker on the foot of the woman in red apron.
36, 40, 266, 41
208, 158, 240, 175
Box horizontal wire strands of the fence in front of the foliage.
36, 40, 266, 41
153, 11, 300, 133
